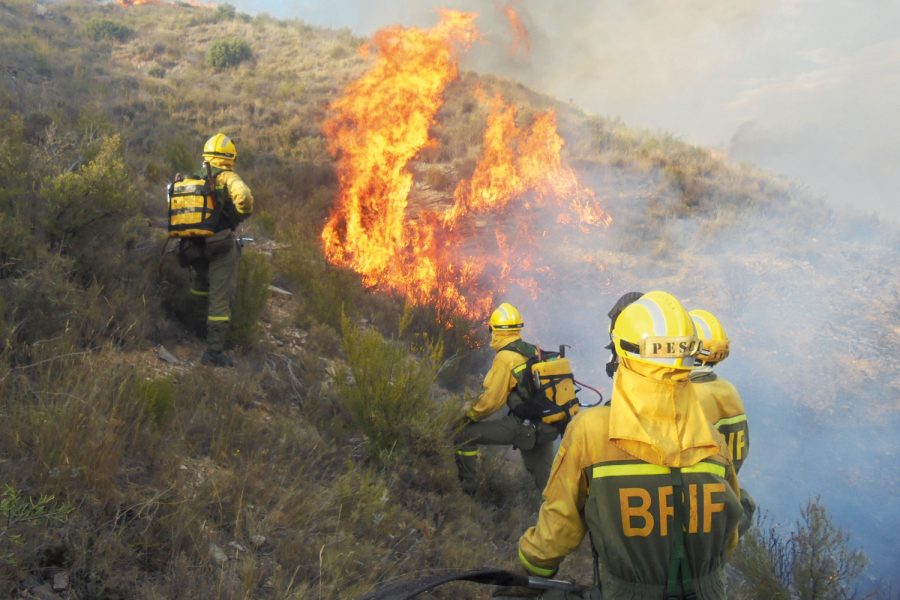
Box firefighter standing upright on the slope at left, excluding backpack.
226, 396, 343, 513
178, 133, 253, 367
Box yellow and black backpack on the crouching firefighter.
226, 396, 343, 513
502, 340, 580, 428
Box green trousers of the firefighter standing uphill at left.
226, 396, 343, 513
190, 242, 241, 352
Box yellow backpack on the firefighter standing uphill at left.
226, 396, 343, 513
167, 162, 222, 238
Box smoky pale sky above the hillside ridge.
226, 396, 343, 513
235, 0, 900, 222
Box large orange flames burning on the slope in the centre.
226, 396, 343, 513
321, 11, 610, 322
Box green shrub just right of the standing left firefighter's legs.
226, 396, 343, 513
229, 250, 272, 348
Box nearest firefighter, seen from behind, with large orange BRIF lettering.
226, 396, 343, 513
510, 291, 742, 600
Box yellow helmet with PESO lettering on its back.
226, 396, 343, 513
612, 291, 700, 369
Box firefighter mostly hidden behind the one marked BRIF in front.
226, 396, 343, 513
689, 310, 756, 535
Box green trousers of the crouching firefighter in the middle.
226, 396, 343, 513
454, 415, 558, 493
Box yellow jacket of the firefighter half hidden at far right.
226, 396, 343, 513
691, 367, 750, 473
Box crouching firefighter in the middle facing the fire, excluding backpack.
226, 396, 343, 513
454, 302, 559, 494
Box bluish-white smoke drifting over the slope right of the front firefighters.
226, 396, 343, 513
509, 190, 900, 586
